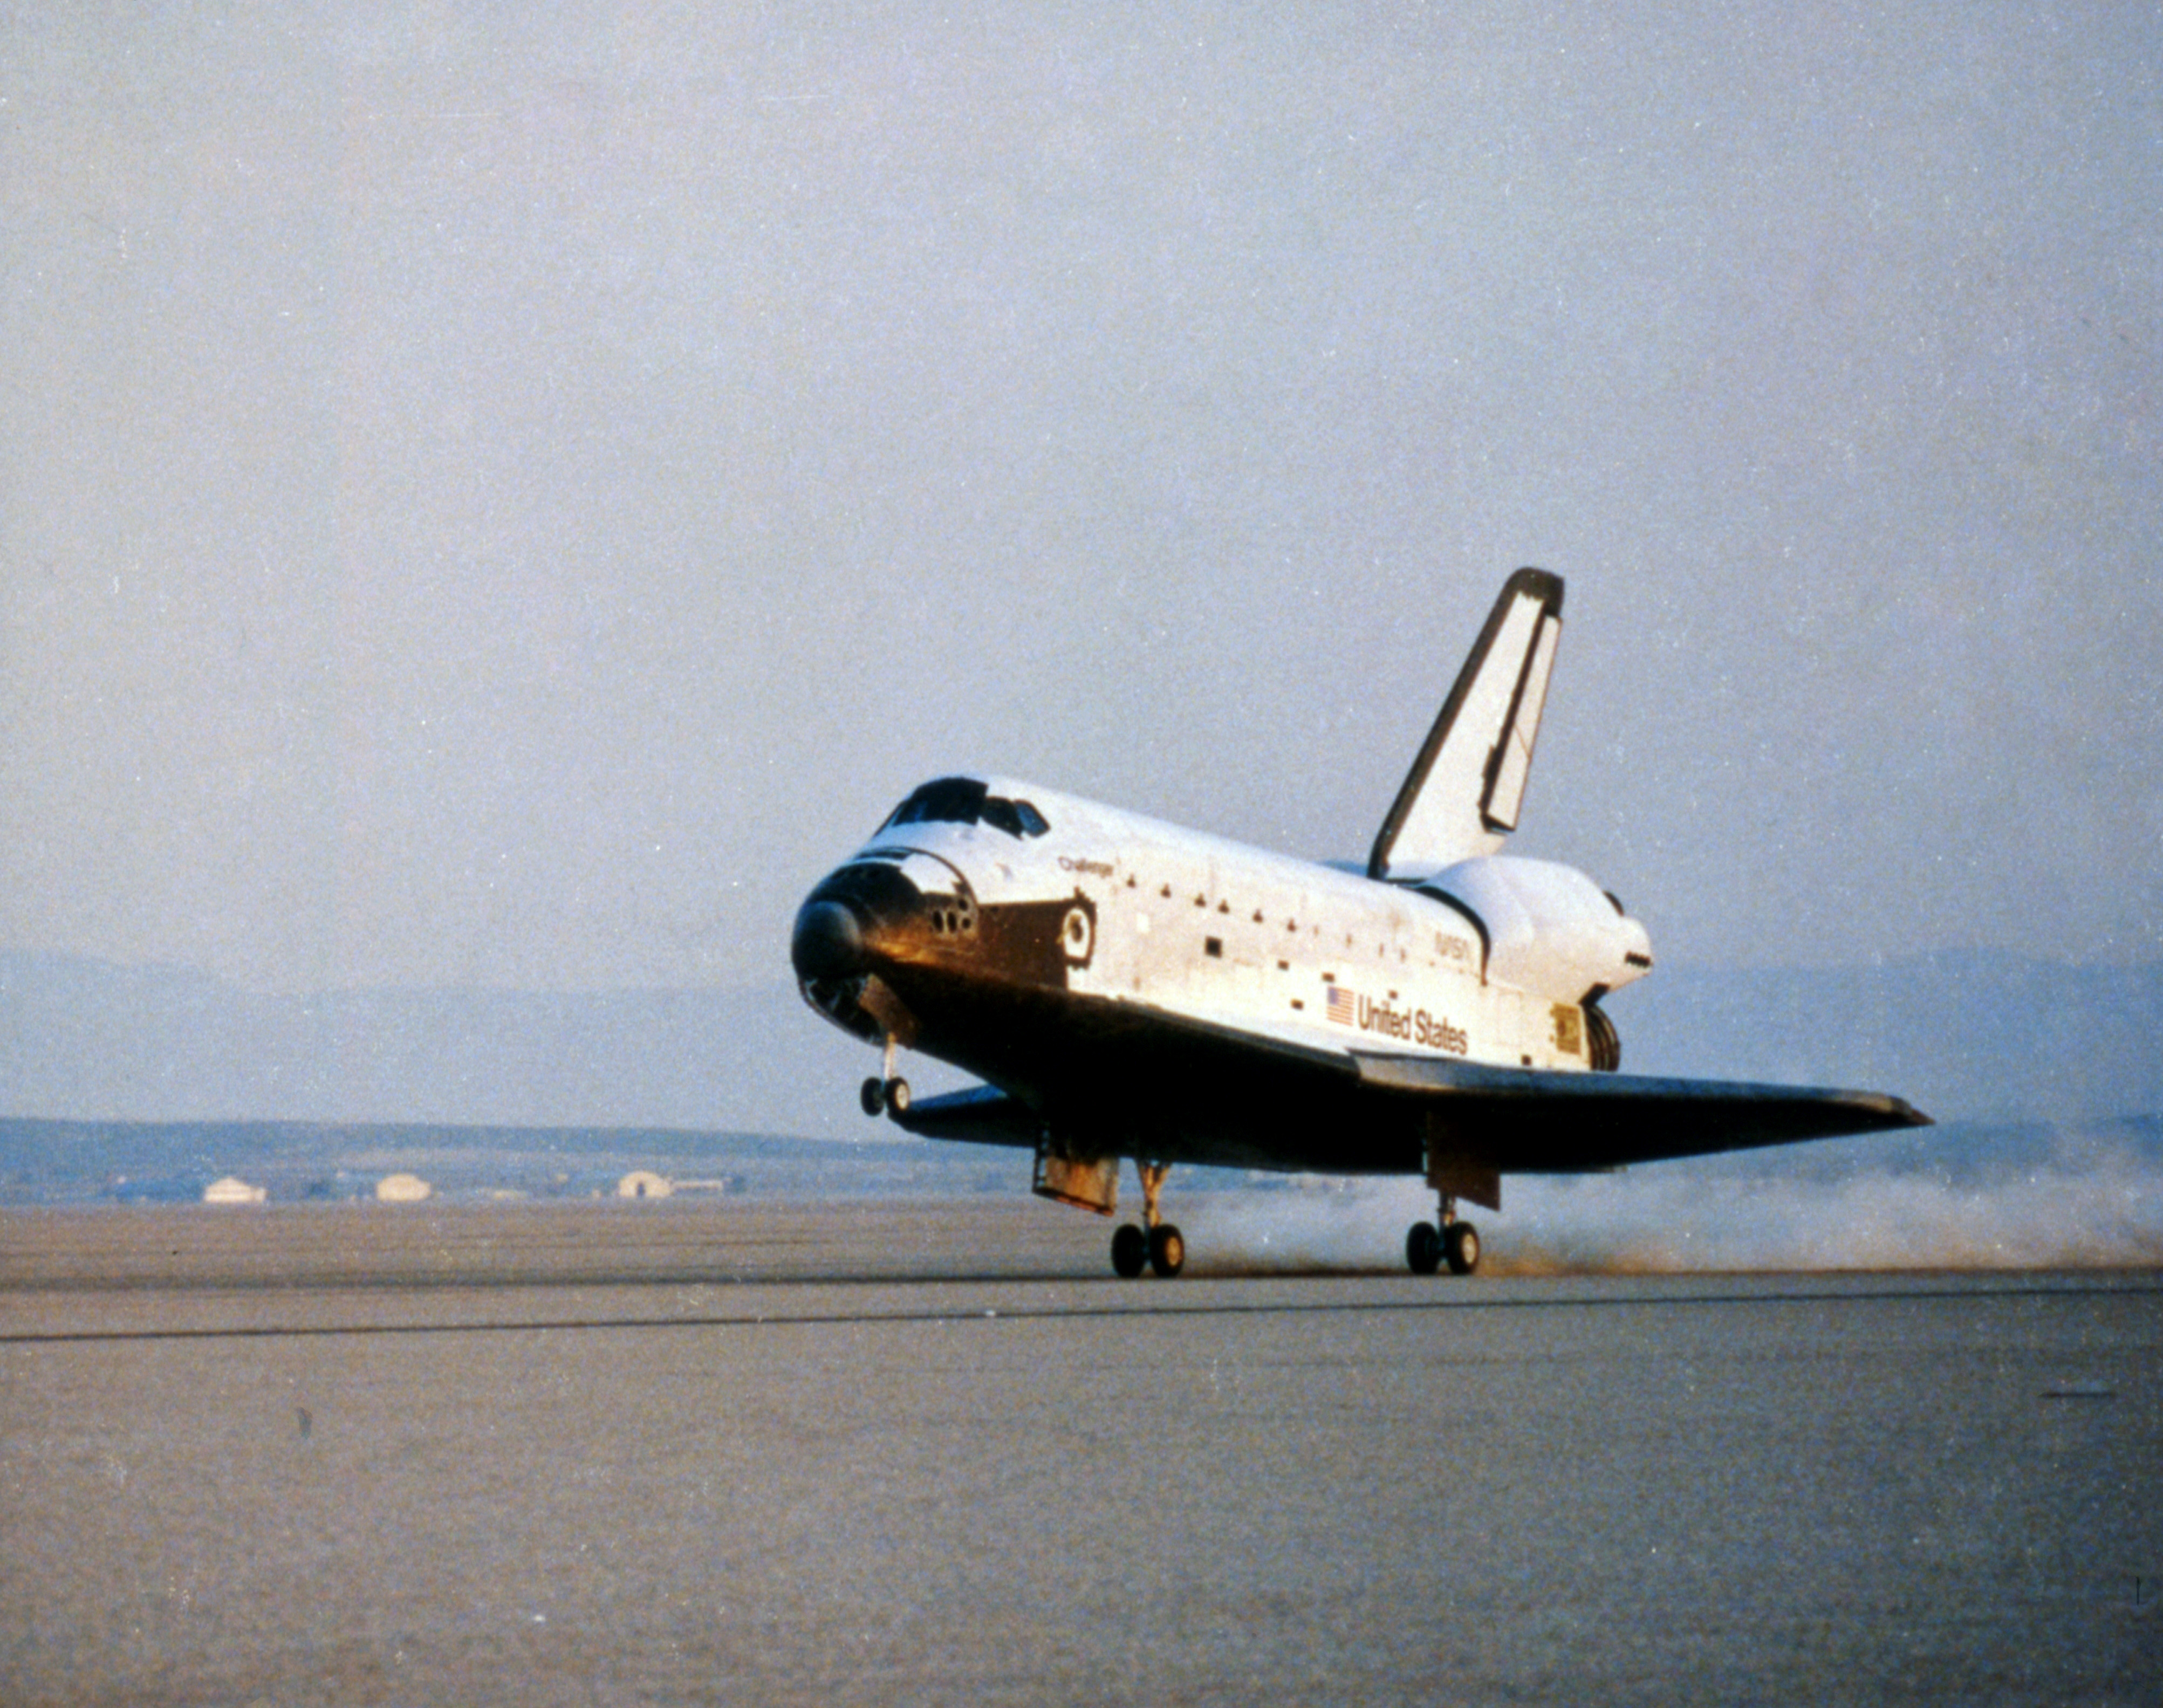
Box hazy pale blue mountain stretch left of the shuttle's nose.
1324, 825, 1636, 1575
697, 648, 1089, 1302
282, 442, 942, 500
0, 954, 880, 1137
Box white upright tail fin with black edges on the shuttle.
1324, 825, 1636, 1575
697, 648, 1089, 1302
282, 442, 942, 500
1367, 568, 1562, 878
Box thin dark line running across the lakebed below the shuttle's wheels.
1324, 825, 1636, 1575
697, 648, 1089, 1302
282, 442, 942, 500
0, 1282, 2163, 1347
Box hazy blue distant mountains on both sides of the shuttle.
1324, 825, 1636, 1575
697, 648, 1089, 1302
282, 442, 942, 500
0, 951, 2163, 1137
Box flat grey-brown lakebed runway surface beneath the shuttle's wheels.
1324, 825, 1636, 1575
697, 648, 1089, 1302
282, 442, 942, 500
0, 1200, 2163, 1704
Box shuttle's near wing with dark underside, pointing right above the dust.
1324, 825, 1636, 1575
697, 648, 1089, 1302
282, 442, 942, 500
1354, 1053, 1932, 1174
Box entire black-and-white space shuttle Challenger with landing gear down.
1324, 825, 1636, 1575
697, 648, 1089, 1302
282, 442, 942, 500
792, 568, 1927, 1275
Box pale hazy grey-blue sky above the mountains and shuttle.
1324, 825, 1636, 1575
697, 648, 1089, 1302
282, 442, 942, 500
0, 0, 2163, 994
